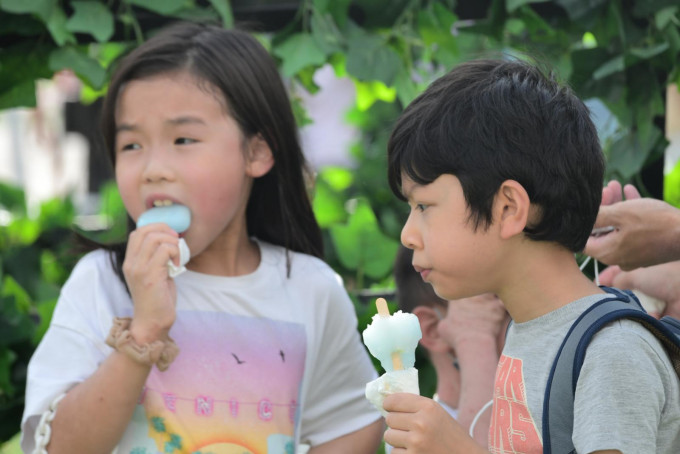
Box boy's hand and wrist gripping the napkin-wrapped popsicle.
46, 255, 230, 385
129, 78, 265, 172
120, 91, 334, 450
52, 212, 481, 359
383, 393, 486, 454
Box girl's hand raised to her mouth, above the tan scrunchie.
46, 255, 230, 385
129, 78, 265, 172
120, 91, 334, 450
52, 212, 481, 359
123, 223, 179, 344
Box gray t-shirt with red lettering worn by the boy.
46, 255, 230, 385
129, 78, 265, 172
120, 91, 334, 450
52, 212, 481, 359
489, 295, 680, 454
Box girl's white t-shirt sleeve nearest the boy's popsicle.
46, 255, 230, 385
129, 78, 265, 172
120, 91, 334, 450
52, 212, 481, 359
300, 272, 380, 446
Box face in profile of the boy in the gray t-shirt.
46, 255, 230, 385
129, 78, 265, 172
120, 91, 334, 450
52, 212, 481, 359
401, 174, 500, 300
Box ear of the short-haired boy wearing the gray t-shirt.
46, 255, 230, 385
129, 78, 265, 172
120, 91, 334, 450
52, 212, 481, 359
494, 180, 532, 239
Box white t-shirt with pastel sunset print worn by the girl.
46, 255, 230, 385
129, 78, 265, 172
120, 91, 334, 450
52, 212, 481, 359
21, 242, 380, 454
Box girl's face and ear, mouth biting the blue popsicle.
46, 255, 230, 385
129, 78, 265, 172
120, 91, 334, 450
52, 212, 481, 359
115, 73, 273, 270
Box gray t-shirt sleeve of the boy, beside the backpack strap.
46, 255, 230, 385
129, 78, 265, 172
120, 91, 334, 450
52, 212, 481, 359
573, 320, 677, 454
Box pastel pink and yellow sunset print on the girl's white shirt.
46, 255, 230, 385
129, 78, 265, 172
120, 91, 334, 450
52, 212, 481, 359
118, 312, 306, 454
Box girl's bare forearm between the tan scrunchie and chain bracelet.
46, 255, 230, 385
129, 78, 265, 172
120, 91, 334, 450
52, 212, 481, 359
48, 351, 151, 454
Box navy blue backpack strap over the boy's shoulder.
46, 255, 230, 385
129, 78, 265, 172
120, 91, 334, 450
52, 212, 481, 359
543, 286, 680, 454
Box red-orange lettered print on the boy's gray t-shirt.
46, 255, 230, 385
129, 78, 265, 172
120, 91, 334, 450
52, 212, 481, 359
489, 355, 543, 454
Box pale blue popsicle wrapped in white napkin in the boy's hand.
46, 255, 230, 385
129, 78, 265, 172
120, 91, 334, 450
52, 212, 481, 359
363, 298, 423, 416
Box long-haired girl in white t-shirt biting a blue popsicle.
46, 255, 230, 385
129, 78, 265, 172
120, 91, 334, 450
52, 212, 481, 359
22, 24, 382, 454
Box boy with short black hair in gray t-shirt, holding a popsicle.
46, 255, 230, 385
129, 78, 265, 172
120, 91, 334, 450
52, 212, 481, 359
384, 60, 680, 454
